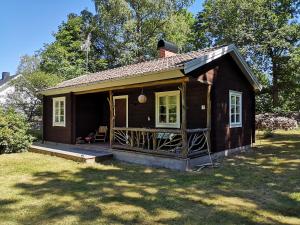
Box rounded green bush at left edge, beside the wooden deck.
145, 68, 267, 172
0, 108, 32, 154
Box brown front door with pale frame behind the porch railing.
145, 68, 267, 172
114, 95, 128, 127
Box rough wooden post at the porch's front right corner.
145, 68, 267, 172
181, 82, 188, 158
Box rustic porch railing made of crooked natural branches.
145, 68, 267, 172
112, 127, 208, 158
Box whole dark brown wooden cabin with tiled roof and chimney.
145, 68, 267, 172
43, 40, 261, 171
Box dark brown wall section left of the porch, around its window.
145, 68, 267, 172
43, 93, 72, 144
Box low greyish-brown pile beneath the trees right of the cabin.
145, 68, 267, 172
255, 113, 298, 131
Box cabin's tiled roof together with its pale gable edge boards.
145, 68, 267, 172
42, 45, 260, 95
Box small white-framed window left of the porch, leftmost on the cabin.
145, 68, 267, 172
53, 97, 66, 127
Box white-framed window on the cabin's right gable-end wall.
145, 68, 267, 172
229, 91, 242, 127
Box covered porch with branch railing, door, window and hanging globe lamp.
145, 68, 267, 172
72, 77, 211, 159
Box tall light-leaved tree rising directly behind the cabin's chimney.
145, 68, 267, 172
94, 0, 192, 67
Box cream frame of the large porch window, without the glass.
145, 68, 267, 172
155, 91, 180, 128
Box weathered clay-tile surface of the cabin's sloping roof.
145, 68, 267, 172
48, 46, 223, 90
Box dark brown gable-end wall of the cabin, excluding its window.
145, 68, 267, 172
211, 55, 255, 151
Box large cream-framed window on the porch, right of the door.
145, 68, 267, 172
155, 91, 180, 128
